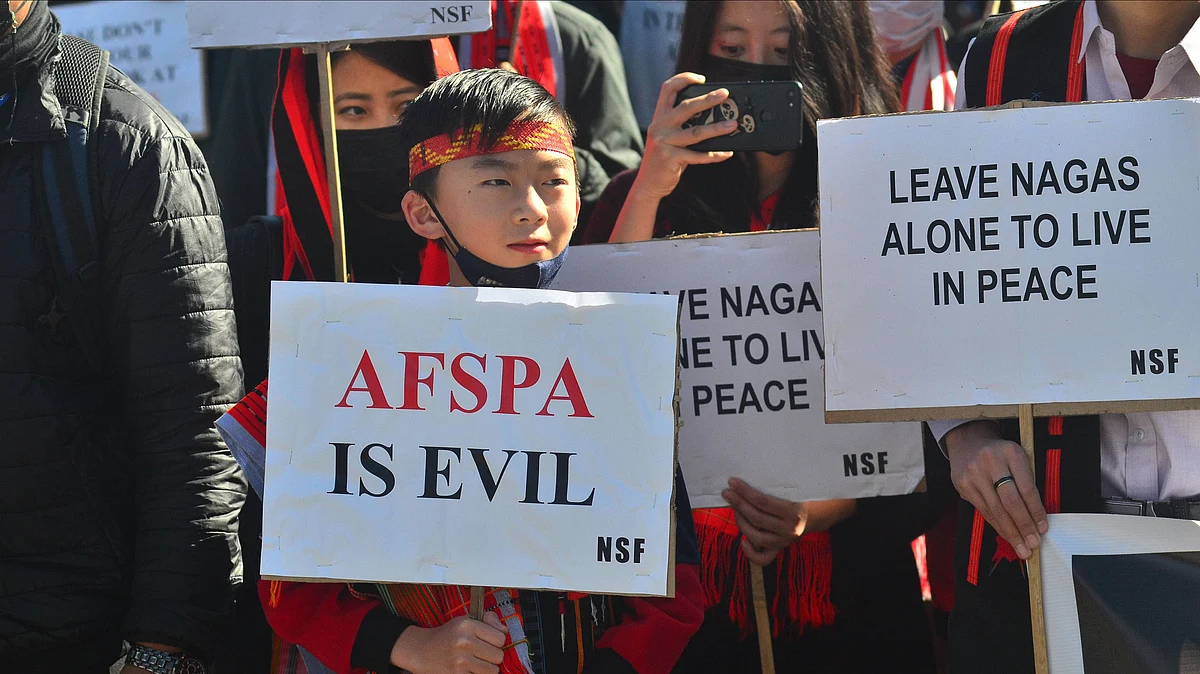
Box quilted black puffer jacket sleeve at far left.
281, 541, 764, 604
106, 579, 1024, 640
92, 71, 246, 657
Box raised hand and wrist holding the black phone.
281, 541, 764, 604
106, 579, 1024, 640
608, 72, 738, 242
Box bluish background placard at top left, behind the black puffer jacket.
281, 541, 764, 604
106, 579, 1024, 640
54, 0, 209, 138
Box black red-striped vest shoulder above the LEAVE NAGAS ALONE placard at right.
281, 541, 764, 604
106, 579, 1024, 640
959, 0, 1085, 108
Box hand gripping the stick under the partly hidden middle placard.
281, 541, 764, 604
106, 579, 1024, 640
721, 477, 857, 566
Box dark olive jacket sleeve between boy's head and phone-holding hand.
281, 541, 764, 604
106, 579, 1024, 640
553, 2, 644, 227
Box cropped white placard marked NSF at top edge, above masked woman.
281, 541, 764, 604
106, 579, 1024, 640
187, 0, 492, 49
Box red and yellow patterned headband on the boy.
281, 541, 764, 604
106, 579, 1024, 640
408, 121, 575, 181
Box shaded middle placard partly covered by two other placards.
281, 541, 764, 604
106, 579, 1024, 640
554, 230, 925, 507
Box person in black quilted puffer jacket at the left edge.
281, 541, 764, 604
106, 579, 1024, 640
0, 0, 246, 674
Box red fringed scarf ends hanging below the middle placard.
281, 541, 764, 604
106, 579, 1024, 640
692, 507, 836, 638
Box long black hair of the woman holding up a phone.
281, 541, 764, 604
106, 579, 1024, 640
660, 0, 900, 234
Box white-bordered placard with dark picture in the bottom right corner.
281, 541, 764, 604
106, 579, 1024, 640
1040, 514, 1200, 674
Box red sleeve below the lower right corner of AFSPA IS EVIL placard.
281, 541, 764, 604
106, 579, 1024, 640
596, 564, 704, 674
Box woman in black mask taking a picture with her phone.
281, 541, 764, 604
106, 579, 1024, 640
584, 0, 936, 674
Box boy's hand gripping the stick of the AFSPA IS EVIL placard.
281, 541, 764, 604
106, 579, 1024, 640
391, 613, 509, 674
